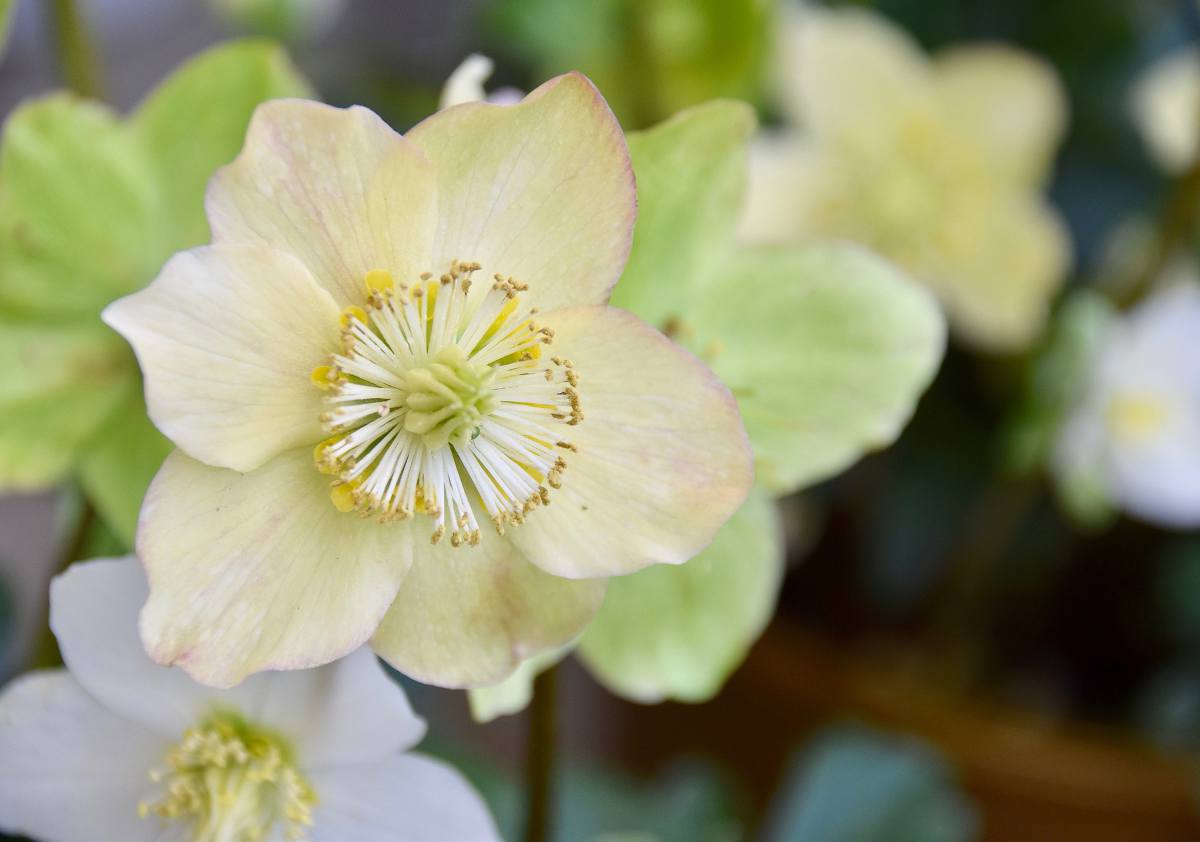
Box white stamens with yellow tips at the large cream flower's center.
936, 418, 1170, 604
312, 260, 583, 547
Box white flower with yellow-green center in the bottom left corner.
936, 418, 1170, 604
0, 557, 498, 842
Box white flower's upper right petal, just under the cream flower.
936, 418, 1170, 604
227, 646, 425, 769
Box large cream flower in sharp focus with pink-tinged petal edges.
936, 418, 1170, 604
104, 74, 751, 686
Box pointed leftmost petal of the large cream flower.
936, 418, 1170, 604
104, 246, 340, 471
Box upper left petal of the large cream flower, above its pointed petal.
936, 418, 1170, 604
206, 100, 439, 306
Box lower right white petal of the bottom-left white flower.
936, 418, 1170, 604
308, 754, 500, 842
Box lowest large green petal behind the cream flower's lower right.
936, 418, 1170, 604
578, 487, 784, 702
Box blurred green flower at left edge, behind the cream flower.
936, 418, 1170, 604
0, 42, 307, 543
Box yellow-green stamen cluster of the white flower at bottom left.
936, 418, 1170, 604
138, 714, 317, 842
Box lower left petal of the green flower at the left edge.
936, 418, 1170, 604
0, 321, 134, 489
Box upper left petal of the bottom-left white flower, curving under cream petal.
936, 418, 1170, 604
50, 555, 212, 739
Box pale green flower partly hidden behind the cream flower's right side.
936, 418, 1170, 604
458, 61, 944, 718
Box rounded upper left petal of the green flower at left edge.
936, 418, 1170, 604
0, 94, 166, 318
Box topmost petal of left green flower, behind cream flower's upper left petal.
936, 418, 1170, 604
131, 40, 312, 252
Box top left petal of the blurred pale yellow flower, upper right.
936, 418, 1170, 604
776, 6, 936, 144
